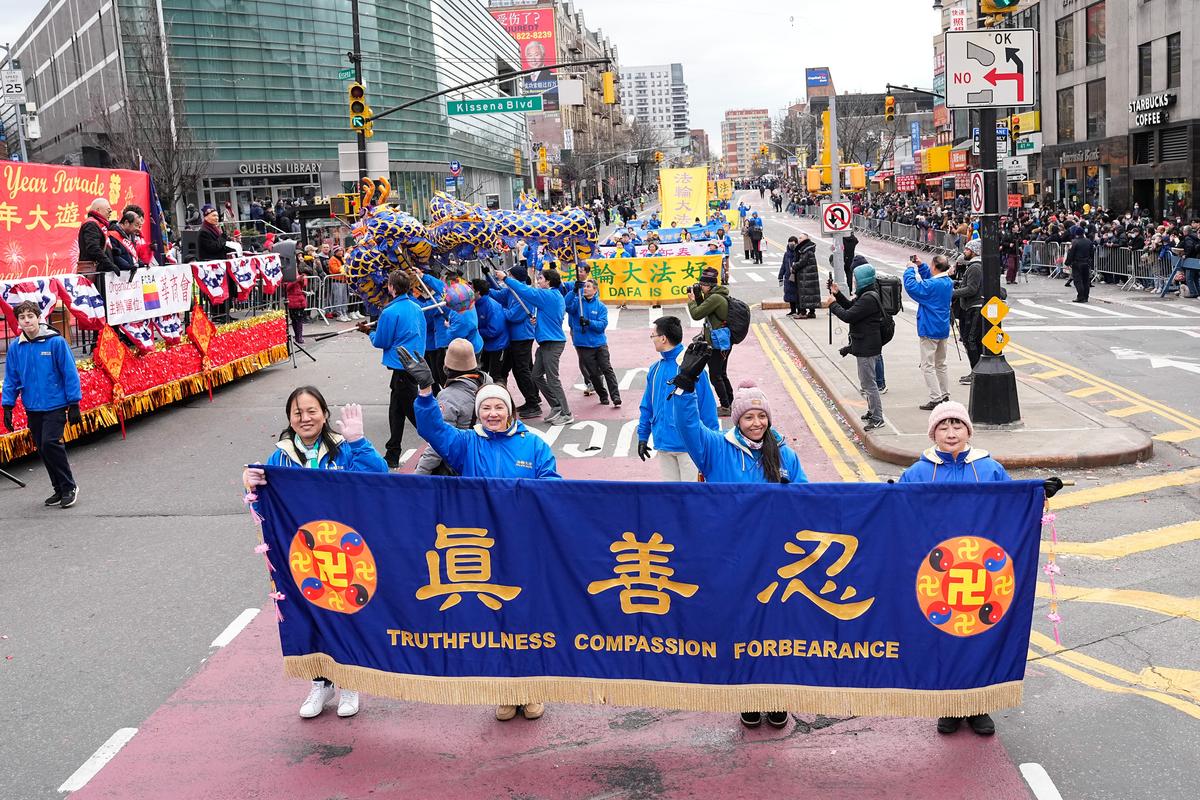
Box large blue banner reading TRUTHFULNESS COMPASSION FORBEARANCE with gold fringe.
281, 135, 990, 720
257, 467, 1044, 716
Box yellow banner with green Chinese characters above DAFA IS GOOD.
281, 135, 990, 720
588, 255, 721, 305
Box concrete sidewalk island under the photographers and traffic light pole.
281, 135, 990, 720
773, 309, 1153, 468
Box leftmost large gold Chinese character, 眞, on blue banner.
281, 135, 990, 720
416, 524, 521, 612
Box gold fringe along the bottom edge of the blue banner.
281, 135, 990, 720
283, 652, 1024, 717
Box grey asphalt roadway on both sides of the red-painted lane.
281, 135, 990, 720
0, 194, 1200, 800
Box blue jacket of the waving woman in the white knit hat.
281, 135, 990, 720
413, 395, 562, 477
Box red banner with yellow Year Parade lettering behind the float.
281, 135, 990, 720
0, 162, 150, 279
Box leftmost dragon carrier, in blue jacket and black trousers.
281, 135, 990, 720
359, 270, 427, 469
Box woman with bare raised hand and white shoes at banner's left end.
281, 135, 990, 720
241, 388, 388, 720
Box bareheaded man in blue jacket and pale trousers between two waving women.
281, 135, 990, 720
637, 317, 721, 482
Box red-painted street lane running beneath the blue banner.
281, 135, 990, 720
74, 330, 1030, 800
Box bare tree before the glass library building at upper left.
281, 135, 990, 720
96, 22, 212, 222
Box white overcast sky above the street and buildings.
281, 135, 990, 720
0, 0, 938, 143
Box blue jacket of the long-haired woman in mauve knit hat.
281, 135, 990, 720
671, 381, 809, 483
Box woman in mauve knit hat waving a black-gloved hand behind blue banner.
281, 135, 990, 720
671, 342, 809, 728
